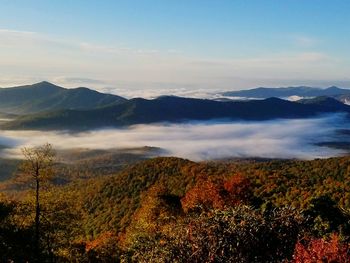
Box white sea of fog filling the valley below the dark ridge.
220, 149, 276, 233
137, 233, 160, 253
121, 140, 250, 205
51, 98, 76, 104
0, 114, 349, 161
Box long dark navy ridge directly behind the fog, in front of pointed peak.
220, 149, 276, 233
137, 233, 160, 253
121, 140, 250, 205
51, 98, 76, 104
2, 96, 350, 130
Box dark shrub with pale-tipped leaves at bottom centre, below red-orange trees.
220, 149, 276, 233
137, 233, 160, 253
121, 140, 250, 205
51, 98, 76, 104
128, 205, 303, 263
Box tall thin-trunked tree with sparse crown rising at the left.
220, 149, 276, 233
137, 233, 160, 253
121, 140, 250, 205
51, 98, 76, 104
20, 143, 55, 261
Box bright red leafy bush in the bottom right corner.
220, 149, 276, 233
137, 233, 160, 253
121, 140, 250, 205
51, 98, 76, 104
293, 234, 350, 263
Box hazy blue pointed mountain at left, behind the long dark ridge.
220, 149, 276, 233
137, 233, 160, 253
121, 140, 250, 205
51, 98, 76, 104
0, 81, 126, 114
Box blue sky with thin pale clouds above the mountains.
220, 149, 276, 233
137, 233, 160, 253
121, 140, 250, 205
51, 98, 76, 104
0, 0, 350, 94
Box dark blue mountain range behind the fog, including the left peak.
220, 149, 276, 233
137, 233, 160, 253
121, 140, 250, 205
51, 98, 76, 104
0, 82, 350, 130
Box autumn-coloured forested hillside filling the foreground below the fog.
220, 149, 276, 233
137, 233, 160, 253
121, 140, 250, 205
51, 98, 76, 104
0, 154, 350, 262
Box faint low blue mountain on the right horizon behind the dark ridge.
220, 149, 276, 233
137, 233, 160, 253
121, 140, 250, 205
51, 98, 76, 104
222, 86, 350, 99
